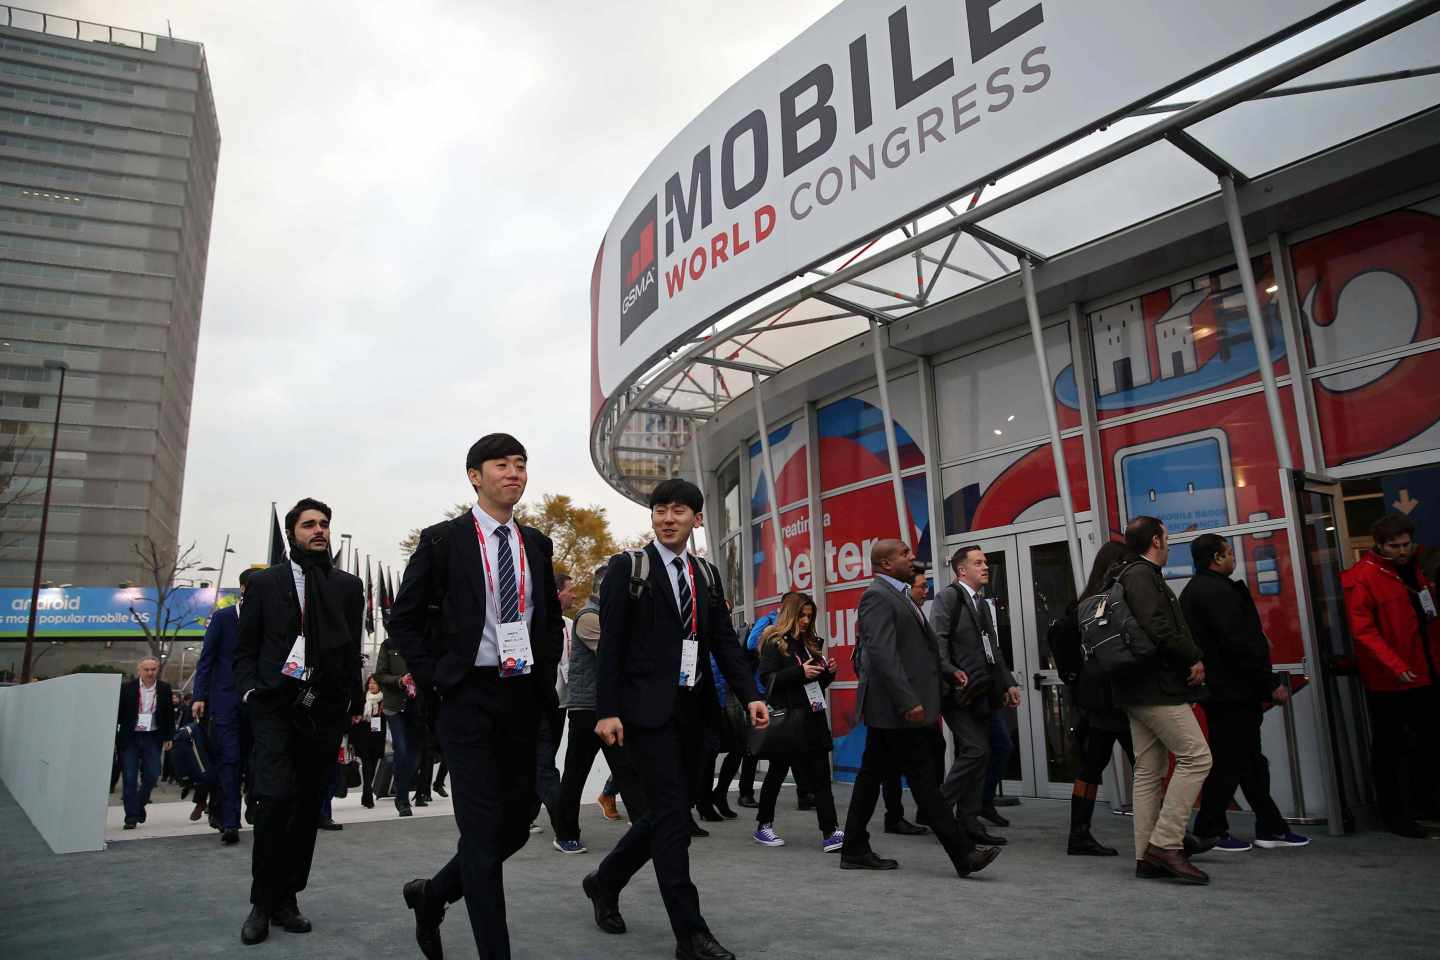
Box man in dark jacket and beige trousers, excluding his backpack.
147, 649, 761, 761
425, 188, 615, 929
1105, 517, 1211, 884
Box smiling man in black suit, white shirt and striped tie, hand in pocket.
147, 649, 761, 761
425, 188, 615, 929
390, 433, 564, 960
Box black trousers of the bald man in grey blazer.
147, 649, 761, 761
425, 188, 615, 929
841, 727, 975, 871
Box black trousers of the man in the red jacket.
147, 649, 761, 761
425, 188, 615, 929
1365, 687, 1440, 826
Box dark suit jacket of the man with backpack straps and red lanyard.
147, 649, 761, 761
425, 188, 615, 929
595, 544, 760, 727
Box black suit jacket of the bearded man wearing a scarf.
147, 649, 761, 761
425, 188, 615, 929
233, 560, 364, 714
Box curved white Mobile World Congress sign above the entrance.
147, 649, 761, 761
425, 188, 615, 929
592, 0, 1351, 413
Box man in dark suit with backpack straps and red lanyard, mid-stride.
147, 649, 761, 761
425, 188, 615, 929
583, 479, 769, 960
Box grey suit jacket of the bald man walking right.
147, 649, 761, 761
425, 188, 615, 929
855, 577, 942, 730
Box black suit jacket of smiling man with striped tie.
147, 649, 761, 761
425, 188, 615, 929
390, 511, 564, 702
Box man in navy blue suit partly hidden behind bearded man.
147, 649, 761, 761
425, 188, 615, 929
190, 570, 255, 843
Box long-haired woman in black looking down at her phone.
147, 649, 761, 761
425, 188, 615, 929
753, 593, 845, 853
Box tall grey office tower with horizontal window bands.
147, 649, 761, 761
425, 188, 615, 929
0, 6, 220, 586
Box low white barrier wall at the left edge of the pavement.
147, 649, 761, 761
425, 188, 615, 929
0, 674, 121, 853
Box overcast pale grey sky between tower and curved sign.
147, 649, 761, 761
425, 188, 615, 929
50, 0, 834, 584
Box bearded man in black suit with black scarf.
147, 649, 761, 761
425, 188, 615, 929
233, 497, 364, 944
